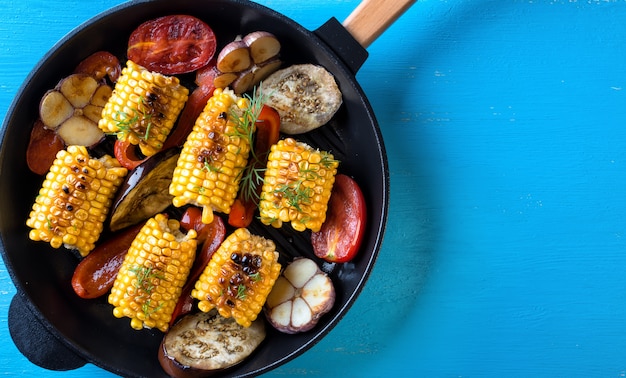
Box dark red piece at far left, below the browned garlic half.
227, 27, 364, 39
26, 120, 65, 175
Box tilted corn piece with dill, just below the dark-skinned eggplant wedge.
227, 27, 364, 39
108, 214, 197, 332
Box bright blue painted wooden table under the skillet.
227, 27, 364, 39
0, 0, 626, 378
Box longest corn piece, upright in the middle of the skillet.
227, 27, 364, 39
169, 89, 254, 223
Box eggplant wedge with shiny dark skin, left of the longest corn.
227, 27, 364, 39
109, 148, 180, 231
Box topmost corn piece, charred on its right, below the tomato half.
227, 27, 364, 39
98, 60, 189, 156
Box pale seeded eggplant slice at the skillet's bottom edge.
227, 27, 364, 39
159, 310, 266, 378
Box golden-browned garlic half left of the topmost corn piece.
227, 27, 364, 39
39, 73, 111, 147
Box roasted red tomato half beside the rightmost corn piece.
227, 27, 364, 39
311, 174, 367, 263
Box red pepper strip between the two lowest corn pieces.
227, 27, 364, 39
170, 206, 226, 325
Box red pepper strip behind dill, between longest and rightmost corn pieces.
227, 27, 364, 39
228, 105, 280, 227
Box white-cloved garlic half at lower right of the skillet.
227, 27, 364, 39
265, 258, 335, 333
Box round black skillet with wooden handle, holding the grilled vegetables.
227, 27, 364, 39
0, 0, 414, 377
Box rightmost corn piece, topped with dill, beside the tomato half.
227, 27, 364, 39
259, 138, 339, 232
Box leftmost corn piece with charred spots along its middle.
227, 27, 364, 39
26, 146, 128, 256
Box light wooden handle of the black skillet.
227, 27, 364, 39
343, 0, 416, 48
